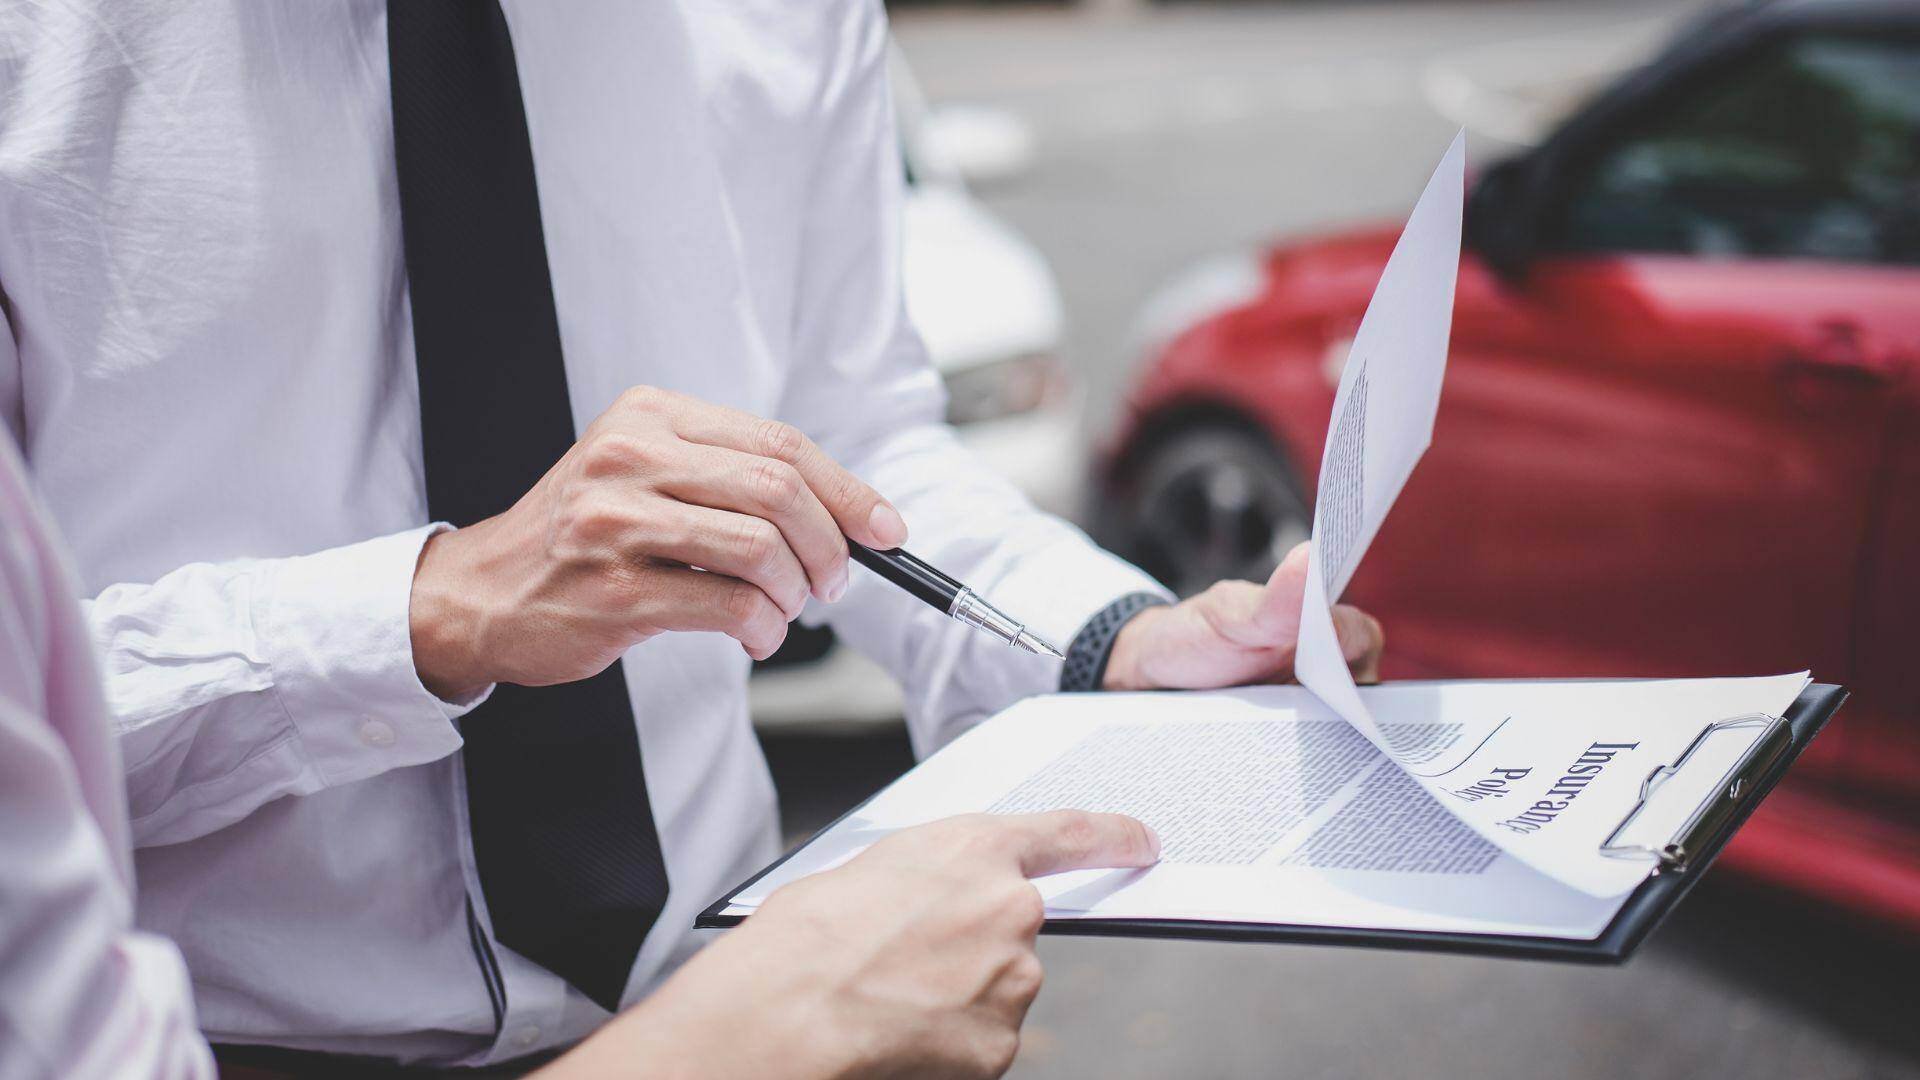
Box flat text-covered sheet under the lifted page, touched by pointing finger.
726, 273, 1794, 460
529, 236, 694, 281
732, 686, 1620, 938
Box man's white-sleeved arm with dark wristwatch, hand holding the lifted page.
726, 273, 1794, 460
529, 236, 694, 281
780, 0, 1380, 753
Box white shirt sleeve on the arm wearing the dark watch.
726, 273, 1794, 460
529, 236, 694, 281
781, 0, 1165, 753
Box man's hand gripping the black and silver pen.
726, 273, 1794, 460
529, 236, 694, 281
411, 386, 906, 700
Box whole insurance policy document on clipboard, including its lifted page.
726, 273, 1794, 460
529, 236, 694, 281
728, 138, 1809, 940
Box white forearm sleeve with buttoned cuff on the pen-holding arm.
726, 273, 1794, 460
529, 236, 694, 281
86, 525, 486, 846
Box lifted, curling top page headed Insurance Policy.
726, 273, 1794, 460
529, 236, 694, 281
1267, 136, 1807, 896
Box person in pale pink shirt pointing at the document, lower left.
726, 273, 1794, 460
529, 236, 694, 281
0, 424, 1156, 1080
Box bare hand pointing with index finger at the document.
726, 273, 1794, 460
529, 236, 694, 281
551, 811, 1160, 1078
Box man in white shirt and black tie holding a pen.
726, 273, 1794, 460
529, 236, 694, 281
0, 0, 1379, 1065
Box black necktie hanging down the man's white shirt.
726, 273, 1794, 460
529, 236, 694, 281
386, 0, 666, 1011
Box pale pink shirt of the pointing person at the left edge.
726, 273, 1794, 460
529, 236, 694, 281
0, 436, 213, 1080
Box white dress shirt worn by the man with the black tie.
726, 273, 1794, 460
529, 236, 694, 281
0, 0, 1154, 1063
